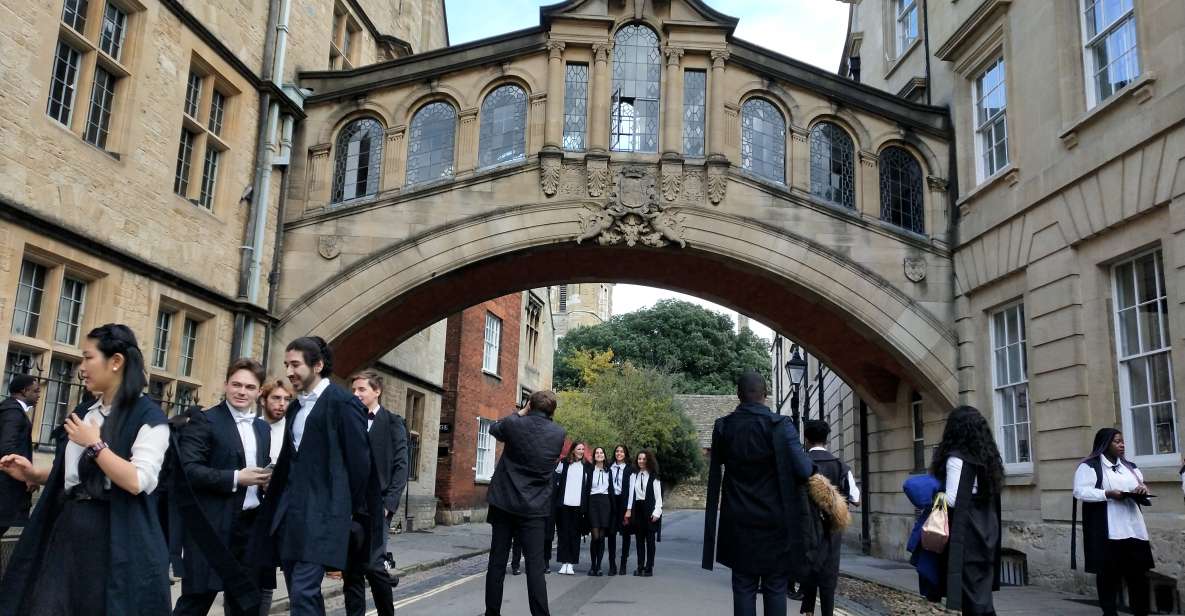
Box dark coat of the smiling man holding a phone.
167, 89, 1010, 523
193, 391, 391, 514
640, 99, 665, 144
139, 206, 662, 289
178, 402, 271, 593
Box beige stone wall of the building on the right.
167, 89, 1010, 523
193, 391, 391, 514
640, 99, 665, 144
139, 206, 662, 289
844, 0, 1185, 591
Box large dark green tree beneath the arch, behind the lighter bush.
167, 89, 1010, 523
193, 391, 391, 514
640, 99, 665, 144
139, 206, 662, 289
555, 300, 770, 394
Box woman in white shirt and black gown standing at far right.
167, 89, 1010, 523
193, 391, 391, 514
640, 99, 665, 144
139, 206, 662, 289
1070, 428, 1154, 616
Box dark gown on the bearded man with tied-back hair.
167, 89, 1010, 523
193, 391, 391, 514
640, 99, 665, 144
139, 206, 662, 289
250, 383, 373, 571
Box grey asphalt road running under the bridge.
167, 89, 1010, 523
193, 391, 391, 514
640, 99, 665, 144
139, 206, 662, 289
328, 512, 843, 616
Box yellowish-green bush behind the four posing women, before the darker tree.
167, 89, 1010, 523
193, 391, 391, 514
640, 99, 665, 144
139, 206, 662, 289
556, 362, 704, 485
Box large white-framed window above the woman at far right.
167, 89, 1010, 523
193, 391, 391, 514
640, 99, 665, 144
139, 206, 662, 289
1113, 250, 1178, 463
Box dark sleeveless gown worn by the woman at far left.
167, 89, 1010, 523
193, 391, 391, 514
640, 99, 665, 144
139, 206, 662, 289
0, 396, 172, 616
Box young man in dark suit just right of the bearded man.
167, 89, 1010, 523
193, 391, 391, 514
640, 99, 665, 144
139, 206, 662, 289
342, 370, 408, 616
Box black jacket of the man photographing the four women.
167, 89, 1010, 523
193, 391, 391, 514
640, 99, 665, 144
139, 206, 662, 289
486, 411, 564, 518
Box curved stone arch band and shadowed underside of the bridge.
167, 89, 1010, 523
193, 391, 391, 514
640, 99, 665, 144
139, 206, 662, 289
275, 200, 957, 405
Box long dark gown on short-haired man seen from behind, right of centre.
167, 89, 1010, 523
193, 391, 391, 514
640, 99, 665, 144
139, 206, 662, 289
703, 404, 819, 579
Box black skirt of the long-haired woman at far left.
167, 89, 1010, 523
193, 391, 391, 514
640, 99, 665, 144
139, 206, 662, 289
28, 496, 111, 616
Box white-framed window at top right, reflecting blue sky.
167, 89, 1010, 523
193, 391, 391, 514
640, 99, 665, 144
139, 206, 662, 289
1082, 0, 1140, 107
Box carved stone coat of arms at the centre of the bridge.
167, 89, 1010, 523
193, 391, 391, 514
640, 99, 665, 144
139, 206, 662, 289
576, 167, 687, 248
